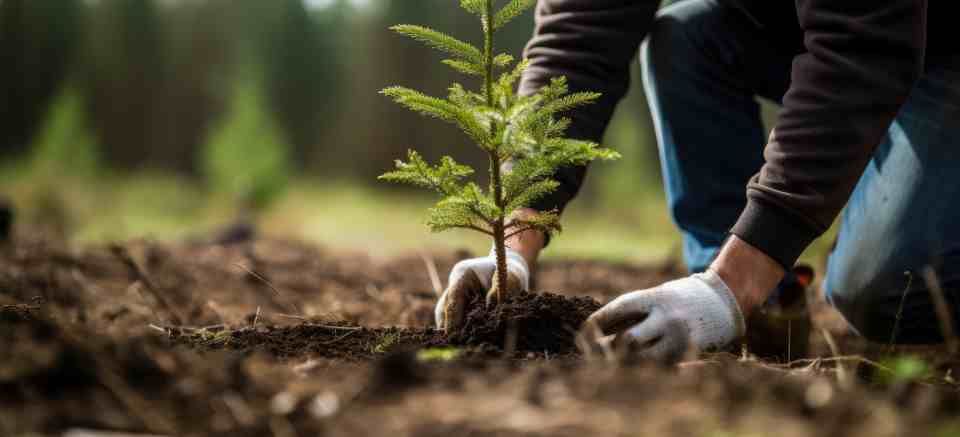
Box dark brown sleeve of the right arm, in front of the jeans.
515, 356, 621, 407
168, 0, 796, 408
732, 0, 926, 268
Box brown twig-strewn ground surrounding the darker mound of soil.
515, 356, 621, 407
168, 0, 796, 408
0, 235, 960, 437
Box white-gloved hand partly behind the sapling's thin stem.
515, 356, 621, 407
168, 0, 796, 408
434, 247, 530, 331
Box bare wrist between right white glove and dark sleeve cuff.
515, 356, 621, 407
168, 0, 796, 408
710, 235, 785, 317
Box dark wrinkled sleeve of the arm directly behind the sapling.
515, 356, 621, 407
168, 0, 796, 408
519, 0, 660, 211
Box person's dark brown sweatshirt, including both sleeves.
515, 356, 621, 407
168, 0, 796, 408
520, 0, 944, 267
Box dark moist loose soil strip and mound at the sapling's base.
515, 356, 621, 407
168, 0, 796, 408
175, 293, 600, 360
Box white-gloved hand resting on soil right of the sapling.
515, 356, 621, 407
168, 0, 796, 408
587, 270, 744, 363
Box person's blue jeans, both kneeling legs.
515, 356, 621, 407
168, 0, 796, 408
641, 0, 960, 343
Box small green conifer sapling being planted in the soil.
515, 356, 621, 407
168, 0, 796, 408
380, 0, 619, 302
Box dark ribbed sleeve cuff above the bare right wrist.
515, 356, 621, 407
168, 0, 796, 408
730, 196, 824, 271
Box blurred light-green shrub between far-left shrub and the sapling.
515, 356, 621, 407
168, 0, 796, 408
200, 76, 293, 212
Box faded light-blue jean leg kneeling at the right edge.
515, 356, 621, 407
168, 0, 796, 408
824, 59, 960, 343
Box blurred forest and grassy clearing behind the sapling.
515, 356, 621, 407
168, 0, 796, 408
0, 0, 804, 259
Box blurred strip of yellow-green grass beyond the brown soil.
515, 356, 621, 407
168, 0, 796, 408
0, 170, 829, 263
